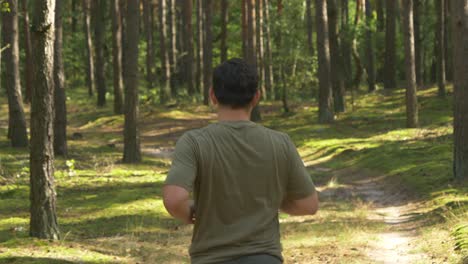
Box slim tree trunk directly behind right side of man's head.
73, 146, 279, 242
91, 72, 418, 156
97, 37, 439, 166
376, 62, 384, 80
247, 0, 261, 122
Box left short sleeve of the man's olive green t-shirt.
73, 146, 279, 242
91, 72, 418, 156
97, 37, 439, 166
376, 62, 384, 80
164, 133, 197, 192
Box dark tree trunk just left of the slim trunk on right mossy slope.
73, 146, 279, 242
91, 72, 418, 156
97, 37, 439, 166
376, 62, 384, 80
384, 0, 398, 89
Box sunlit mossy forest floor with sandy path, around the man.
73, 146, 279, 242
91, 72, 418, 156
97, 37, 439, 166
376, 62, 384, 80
0, 86, 468, 263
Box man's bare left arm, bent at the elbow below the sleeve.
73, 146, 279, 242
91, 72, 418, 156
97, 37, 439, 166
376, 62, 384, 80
163, 185, 194, 224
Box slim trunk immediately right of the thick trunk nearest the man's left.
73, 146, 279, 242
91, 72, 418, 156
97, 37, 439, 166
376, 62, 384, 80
143, 0, 154, 89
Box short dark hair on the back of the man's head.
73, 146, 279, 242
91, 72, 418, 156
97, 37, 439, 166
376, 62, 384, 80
213, 58, 258, 108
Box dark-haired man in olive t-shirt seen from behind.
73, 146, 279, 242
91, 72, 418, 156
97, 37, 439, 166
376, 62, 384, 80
163, 59, 318, 264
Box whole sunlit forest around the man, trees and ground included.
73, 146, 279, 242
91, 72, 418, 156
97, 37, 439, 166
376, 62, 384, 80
0, 0, 468, 263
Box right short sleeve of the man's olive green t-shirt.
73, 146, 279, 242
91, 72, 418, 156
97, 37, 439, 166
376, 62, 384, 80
286, 136, 315, 200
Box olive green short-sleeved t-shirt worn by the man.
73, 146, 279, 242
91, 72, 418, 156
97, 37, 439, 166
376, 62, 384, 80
165, 121, 315, 264
